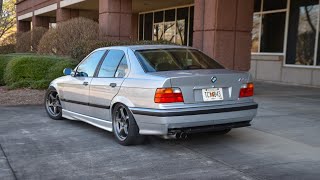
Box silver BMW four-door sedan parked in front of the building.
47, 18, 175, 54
45, 45, 258, 145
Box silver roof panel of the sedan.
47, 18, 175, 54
97, 44, 194, 51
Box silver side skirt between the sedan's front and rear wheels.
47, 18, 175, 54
62, 109, 112, 132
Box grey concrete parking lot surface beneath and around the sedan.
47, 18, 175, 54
0, 83, 320, 180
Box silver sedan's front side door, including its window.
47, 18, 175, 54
62, 50, 106, 115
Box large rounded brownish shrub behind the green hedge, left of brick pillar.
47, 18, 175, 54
38, 17, 99, 56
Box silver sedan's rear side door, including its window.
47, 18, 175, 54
89, 50, 128, 120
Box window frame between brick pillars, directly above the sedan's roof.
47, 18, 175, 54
137, 4, 194, 46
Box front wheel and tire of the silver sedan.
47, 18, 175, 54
44, 87, 63, 120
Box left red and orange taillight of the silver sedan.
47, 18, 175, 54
154, 88, 183, 103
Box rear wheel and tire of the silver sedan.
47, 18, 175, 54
112, 104, 145, 146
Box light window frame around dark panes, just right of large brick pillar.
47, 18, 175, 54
251, 0, 290, 56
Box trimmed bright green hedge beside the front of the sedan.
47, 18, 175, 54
0, 55, 76, 89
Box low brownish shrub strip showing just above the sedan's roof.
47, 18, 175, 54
70, 40, 174, 61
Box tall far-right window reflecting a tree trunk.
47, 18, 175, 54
286, 0, 319, 65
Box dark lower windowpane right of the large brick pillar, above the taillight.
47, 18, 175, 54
260, 12, 286, 53
